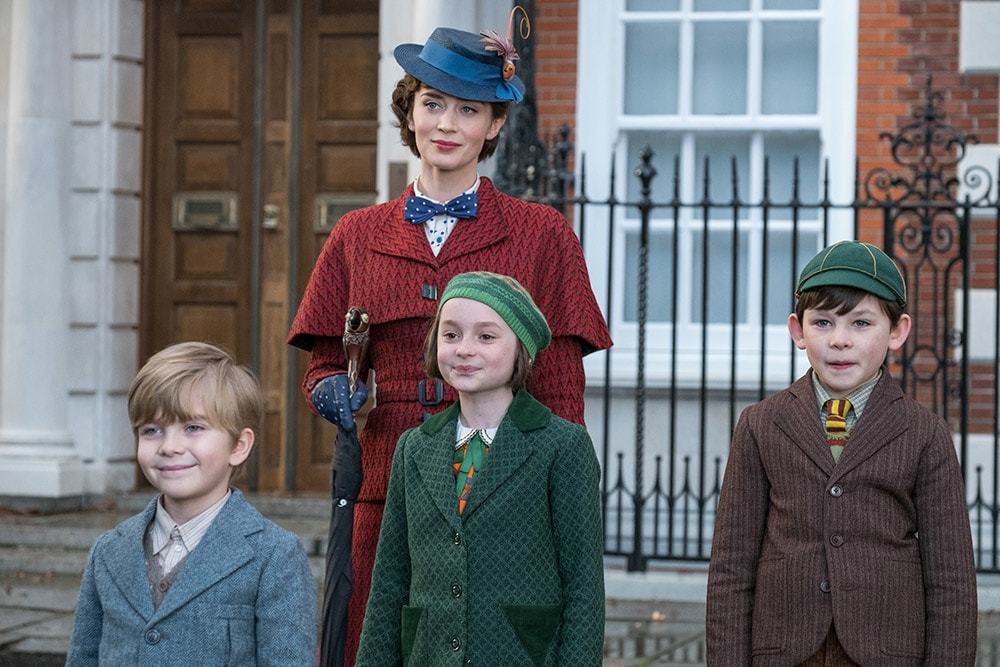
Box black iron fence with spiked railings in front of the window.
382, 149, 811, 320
520, 80, 1000, 572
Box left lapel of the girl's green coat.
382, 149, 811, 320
412, 403, 459, 528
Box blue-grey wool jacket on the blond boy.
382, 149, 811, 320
66, 490, 317, 667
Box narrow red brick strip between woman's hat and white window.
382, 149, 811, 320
532, 0, 578, 138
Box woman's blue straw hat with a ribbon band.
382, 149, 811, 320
393, 28, 524, 103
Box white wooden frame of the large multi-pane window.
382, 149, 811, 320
576, 0, 858, 387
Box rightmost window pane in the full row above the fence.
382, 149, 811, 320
761, 21, 819, 114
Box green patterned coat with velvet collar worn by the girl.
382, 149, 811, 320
357, 391, 604, 667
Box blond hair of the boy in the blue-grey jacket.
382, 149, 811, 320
128, 342, 264, 477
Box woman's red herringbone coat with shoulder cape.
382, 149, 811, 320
288, 178, 611, 661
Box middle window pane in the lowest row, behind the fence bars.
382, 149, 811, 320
691, 229, 749, 324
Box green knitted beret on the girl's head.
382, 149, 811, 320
438, 271, 552, 359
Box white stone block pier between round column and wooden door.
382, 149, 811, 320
68, 0, 143, 493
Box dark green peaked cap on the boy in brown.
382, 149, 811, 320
795, 241, 906, 306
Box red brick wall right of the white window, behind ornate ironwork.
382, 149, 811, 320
857, 0, 998, 432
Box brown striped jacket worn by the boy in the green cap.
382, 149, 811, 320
707, 371, 976, 667
